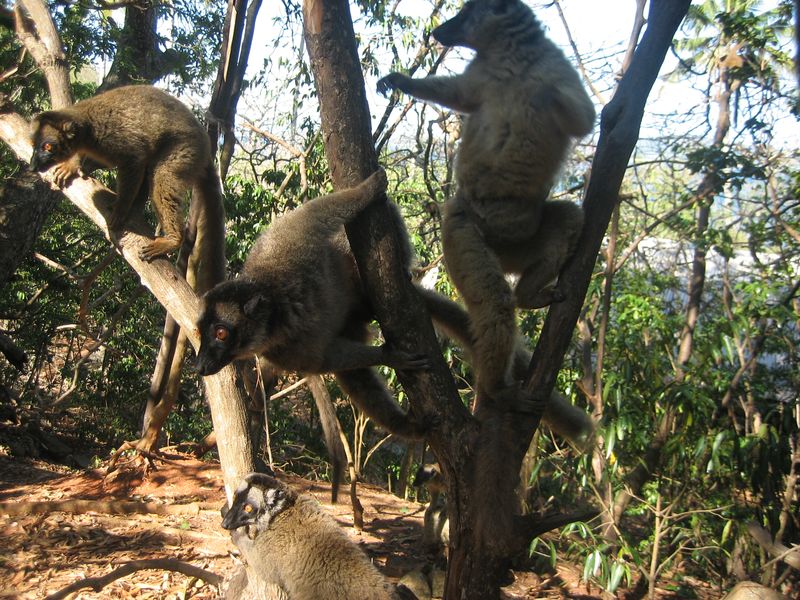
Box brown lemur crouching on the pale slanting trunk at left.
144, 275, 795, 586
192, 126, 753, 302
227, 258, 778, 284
31, 85, 221, 261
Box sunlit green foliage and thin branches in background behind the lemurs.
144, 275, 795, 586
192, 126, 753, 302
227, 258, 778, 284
0, 0, 800, 593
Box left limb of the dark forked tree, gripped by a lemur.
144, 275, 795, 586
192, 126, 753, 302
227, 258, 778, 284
304, 0, 476, 480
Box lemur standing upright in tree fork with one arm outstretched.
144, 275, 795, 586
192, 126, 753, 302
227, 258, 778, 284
378, 0, 595, 403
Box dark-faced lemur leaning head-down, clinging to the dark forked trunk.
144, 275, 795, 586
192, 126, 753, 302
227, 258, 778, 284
196, 169, 430, 437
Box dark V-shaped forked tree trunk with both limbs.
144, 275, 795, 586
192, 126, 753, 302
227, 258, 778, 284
304, 0, 689, 599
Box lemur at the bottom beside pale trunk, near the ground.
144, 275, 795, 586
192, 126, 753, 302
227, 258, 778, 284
222, 473, 412, 600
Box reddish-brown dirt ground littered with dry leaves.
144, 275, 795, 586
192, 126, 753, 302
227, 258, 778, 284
0, 456, 715, 600
